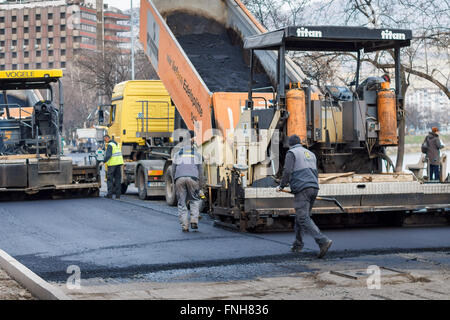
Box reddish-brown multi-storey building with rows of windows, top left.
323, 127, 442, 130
0, 0, 130, 70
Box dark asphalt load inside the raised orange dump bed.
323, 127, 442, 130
167, 12, 272, 92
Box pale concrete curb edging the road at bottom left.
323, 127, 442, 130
0, 250, 71, 300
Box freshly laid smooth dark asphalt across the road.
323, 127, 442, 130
0, 188, 450, 281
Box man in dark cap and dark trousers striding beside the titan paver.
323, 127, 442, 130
277, 135, 333, 258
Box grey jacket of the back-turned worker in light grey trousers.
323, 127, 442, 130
172, 147, 204, 186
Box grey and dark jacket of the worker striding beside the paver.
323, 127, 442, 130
280, 144, 319, 193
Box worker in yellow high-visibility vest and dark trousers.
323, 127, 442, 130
103, 135, 123, 199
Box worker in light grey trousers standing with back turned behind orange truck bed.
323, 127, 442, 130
172, 141, 204, 232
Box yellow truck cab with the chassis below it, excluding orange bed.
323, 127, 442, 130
98, 80, 181, 199
